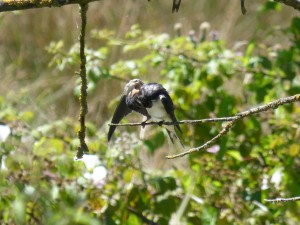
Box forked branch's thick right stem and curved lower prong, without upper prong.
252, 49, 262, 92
166, 94, 300, 159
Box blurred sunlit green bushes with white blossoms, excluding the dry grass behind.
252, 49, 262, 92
0, 5, 300, 225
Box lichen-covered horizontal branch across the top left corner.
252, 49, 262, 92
0, 0, 100, 12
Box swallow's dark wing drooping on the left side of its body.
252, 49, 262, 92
107, 95, 132, 141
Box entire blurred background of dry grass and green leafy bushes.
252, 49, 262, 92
0, 1, 300, 225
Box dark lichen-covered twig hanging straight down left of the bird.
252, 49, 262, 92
77, 4, 89, 159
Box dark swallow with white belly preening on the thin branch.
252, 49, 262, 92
108, 79, 184, 147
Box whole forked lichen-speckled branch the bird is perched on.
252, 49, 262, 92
109, 94, 300, 159
